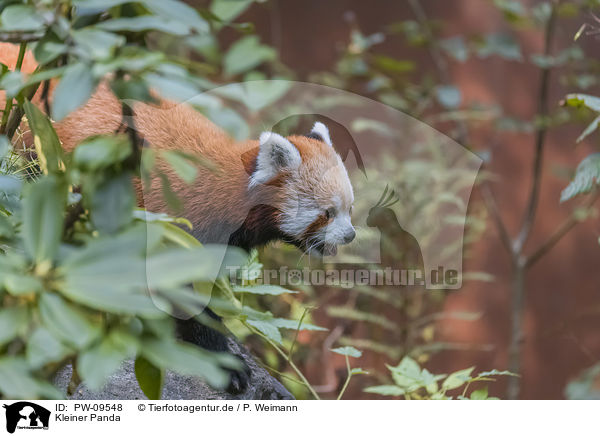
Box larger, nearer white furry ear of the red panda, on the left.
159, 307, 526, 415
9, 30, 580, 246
248, 132, 302, 188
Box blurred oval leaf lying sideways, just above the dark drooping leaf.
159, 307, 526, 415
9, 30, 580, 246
73, 135, 131, 171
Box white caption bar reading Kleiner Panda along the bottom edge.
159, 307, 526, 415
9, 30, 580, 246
0, 400, 600, 436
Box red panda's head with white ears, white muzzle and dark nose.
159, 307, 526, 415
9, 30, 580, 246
248, 122, 355, 255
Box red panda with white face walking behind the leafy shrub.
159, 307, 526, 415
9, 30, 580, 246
0, 44, 355, 392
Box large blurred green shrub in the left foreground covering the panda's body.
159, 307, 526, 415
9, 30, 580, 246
0, 0, 328, 398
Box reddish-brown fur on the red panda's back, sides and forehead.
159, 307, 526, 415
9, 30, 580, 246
0, 44, 346, 242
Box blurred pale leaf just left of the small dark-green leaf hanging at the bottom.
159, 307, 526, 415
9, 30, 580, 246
77, 331, 137, 391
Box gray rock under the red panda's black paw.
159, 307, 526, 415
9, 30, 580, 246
55, 340, 294, 400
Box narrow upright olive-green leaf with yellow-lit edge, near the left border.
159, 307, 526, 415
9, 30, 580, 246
23, 101, 63, 173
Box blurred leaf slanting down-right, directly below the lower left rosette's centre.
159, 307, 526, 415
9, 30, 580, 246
39, 293, 101, 349
